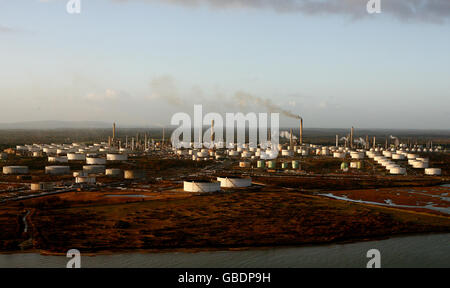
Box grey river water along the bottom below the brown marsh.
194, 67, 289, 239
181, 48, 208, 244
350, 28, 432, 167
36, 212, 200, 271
0, 234, 450, 268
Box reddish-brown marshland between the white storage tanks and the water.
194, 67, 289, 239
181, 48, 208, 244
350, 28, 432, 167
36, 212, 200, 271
0, 183, 450, 253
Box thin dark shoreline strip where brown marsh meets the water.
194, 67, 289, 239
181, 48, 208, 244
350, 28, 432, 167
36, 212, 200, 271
0, 231, 450, 257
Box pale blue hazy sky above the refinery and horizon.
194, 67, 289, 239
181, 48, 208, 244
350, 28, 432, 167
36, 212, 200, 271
0, 0, 450, 129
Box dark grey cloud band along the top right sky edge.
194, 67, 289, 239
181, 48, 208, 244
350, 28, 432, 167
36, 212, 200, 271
110, 0, 450, 23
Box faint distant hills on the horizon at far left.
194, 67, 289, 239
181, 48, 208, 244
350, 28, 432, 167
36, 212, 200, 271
0, 121, 112, 130
